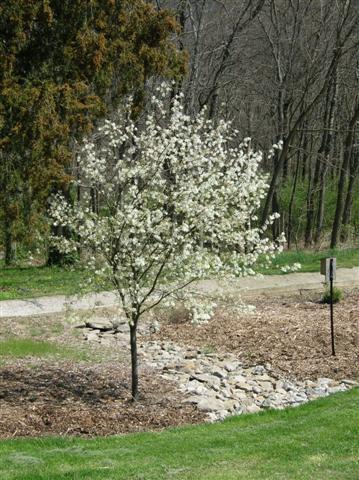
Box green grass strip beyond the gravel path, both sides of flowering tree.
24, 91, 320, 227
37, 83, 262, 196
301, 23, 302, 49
0, 248, 359, 301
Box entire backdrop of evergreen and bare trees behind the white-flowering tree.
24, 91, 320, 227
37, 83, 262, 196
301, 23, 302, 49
0, 0, 359, 265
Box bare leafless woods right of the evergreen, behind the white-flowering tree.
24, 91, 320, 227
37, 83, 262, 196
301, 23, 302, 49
155, 0, 359, 247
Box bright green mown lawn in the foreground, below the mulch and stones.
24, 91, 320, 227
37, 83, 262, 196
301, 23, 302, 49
0, 389, 359, 480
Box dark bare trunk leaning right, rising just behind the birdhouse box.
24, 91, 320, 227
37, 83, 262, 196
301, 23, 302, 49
330, 103, 359, 248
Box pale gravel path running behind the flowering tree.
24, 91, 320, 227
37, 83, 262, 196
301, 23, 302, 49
0, 267, 359, 318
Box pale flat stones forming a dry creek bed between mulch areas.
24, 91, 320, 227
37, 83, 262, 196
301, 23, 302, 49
83, 319, 356, 421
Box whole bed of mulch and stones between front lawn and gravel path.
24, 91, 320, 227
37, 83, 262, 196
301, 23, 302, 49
0, 291, 359, 437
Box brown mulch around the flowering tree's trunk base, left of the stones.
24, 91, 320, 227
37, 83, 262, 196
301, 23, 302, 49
0, 362, 204, 438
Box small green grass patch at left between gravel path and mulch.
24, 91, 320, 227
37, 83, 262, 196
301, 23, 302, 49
0, 338, 87, 362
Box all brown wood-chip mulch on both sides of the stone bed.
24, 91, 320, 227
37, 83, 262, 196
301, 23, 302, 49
0, 290, 359, 438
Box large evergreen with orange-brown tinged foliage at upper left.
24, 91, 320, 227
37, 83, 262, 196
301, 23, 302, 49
0, 0, 184, 263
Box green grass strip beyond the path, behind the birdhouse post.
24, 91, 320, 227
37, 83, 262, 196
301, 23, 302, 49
259, 248, 359, 275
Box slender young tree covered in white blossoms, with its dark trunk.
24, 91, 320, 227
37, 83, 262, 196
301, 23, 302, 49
52, 86, 281, 399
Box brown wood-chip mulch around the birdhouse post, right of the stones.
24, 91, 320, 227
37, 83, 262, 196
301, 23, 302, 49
153, 290, 359, 379
